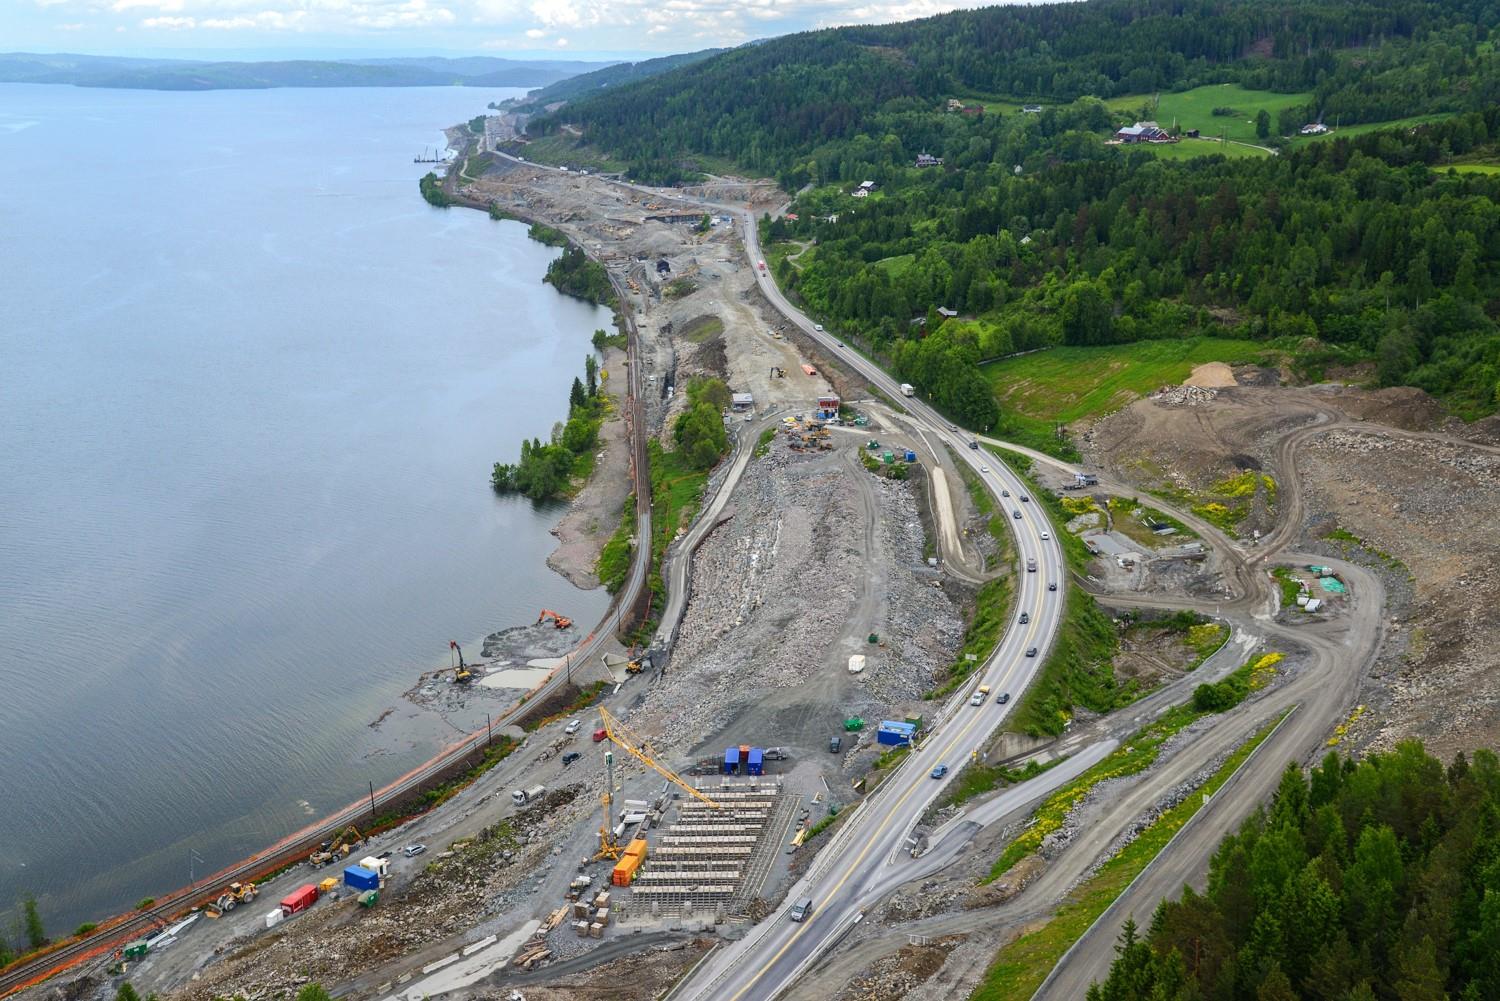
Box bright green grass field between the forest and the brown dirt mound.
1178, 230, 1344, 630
980, 338, 1275, 428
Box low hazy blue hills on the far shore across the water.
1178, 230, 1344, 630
0, 53, 608, 90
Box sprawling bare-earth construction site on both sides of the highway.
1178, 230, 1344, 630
23, 127, 1500, 1001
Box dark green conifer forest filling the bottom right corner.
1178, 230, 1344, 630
1089, 744, 1500, 1001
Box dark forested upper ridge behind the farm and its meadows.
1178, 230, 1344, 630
531, 0, 1500, 177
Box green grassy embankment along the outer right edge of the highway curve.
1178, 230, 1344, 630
989, 446, 1140, 737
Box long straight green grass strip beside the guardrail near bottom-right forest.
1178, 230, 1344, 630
974, 710, 1290, 1001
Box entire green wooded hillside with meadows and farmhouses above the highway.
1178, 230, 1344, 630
531, 0, 1500, 426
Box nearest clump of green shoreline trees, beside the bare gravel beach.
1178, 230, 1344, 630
489, 354, 614, 500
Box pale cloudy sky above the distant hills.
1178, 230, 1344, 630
0, 0, 1026, 59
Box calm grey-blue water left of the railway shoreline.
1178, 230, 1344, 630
0, 84, 609, 933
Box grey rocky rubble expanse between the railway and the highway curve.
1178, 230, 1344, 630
633, 440, 963, 750
